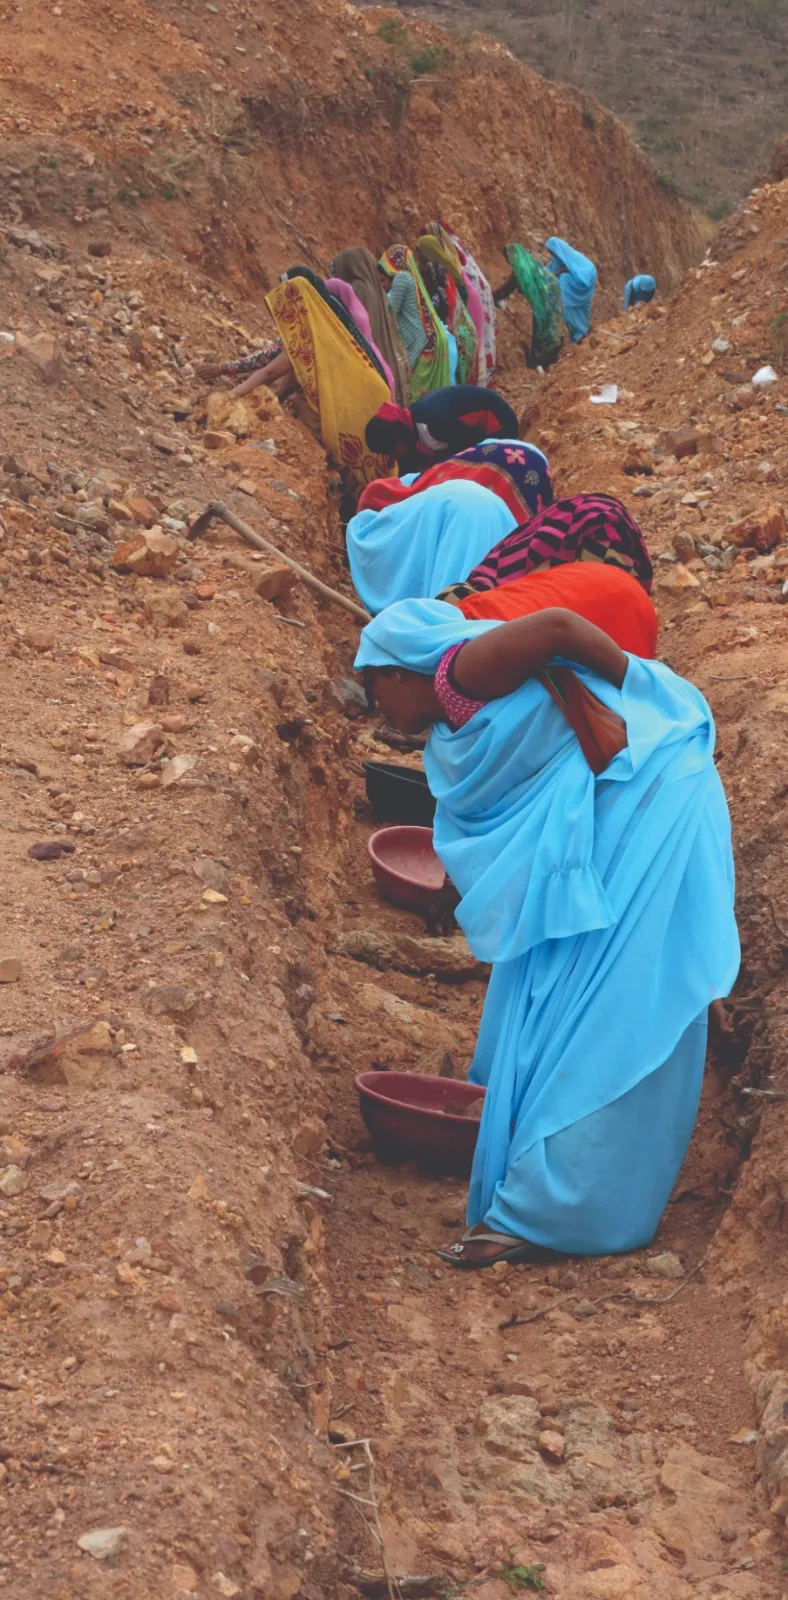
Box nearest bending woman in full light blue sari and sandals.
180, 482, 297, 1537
356, 600, 738, 1267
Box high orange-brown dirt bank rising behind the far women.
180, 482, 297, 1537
0, 0, 700, 320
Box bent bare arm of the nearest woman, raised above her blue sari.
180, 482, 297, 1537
453, 606, 626, 699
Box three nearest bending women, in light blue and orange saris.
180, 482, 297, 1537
348, 438, 738, 1269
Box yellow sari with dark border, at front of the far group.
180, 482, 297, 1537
266, 278, 396, 490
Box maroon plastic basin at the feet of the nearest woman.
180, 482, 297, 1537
356, 1072, 484, 1178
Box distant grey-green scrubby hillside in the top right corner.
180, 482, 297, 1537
394, 0, 788, 221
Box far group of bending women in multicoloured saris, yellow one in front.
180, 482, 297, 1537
197, 221, 605, 498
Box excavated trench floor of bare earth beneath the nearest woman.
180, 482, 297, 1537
251, 528, 782, 1600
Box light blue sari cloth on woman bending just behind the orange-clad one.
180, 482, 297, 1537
348, 480, 517, 614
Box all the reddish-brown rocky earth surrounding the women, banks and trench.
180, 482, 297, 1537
0, 0, 788, 1600
